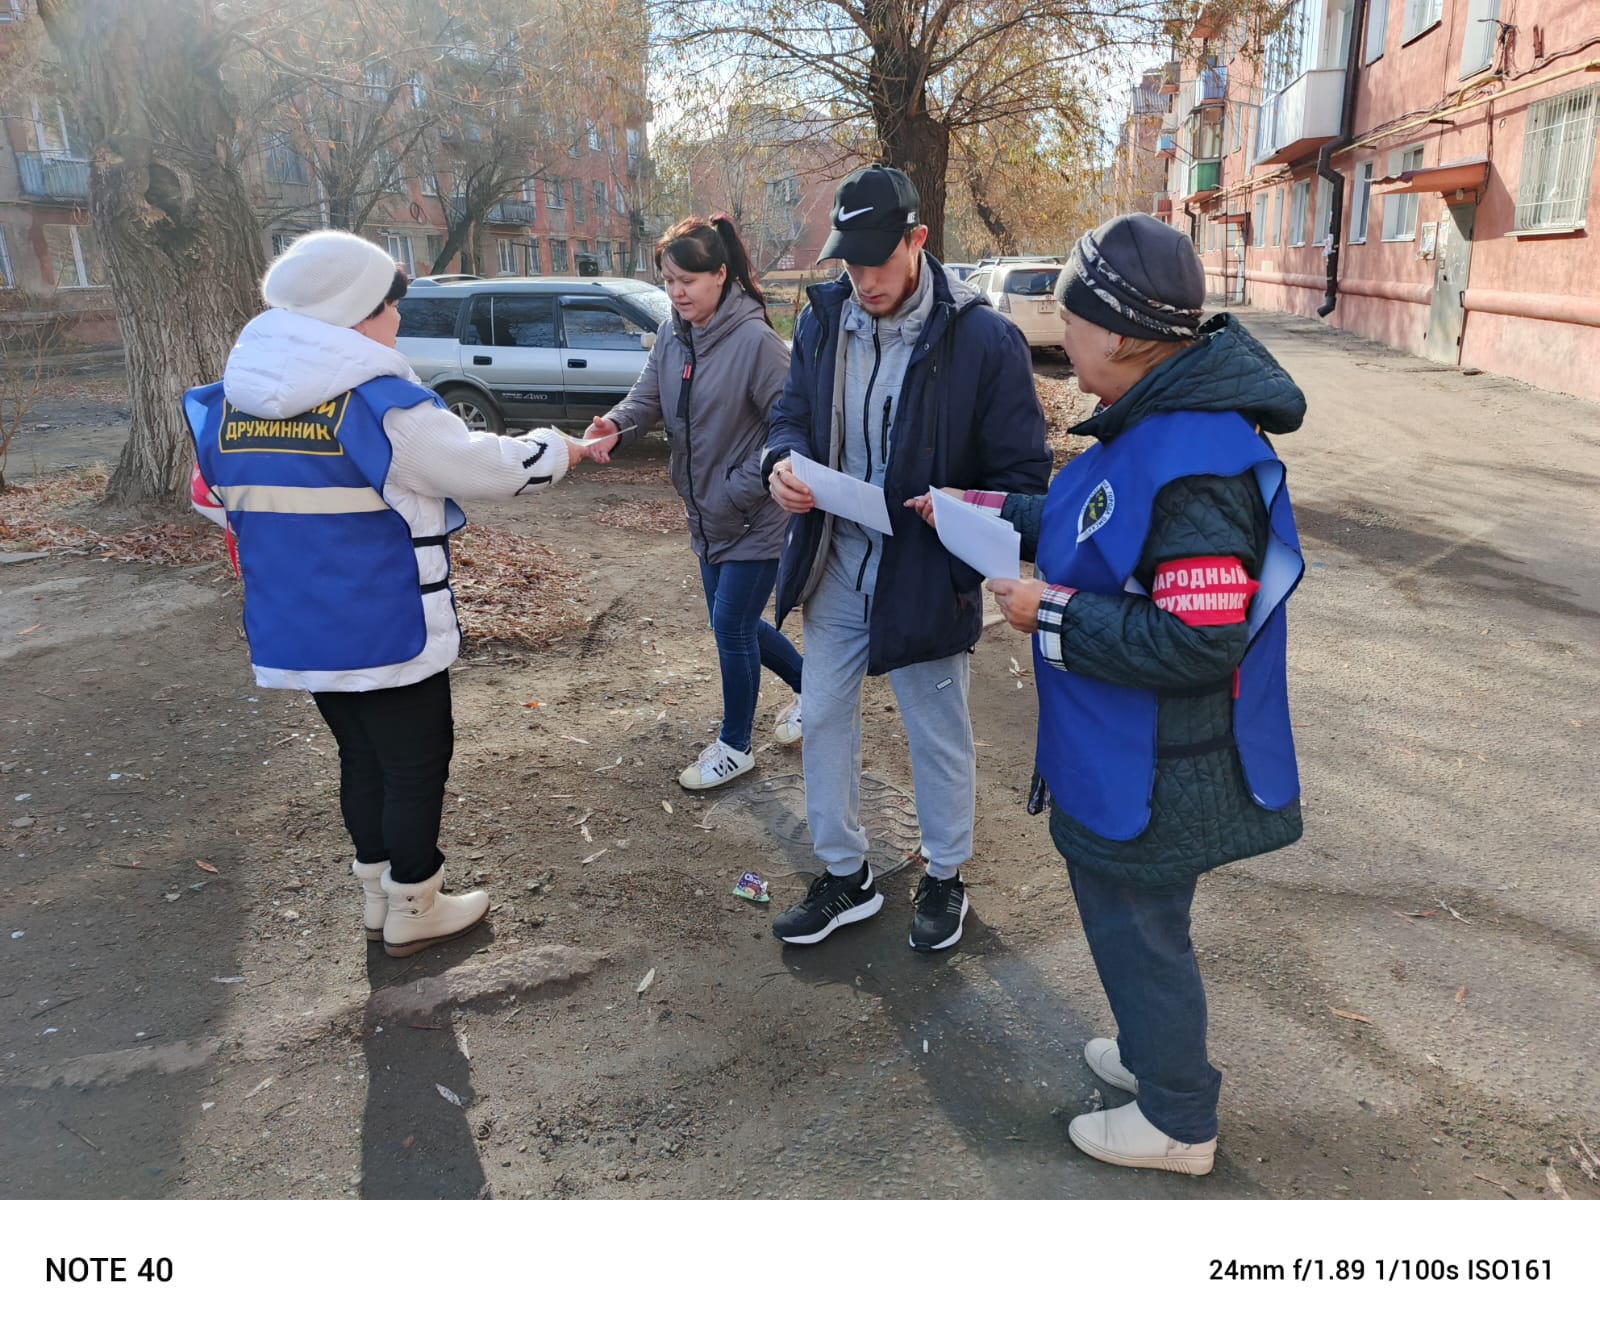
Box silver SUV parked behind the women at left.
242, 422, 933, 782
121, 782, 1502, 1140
395, 277, 672, 434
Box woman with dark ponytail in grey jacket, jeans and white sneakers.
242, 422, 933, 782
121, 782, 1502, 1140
586, 214, 800, 791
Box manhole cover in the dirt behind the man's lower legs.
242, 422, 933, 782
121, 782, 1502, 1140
707, 773, 922, 877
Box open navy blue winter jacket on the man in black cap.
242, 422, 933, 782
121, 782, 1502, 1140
763, 253, 1050, 675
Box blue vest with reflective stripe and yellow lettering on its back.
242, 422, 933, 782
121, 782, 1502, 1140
184, 378, 466, 671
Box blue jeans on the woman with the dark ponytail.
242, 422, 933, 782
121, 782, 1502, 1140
701, 558, 800, 751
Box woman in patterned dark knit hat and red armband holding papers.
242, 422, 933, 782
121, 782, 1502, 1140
921, 214, 1306, 1175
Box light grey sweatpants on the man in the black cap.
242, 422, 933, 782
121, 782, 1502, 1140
802, 571, 978, 880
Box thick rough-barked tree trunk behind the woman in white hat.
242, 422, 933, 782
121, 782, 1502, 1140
38, 0, 264, 502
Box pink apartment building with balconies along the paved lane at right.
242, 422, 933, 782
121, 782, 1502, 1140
1162, 0, 1600, 398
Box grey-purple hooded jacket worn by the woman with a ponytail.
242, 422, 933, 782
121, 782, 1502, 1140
605, 282, 789, 563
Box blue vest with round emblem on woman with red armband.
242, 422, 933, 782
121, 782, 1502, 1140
1034, 411, 1306, 842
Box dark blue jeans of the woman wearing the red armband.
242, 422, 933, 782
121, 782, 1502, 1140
1067, 863, 1222, 1144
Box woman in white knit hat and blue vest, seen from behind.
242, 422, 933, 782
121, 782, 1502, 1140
184, 230, 587, 955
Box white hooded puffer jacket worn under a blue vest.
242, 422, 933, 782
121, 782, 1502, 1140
194, 309, 566, 693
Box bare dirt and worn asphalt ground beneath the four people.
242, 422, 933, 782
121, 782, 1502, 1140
0, 324, 1600, 1199
